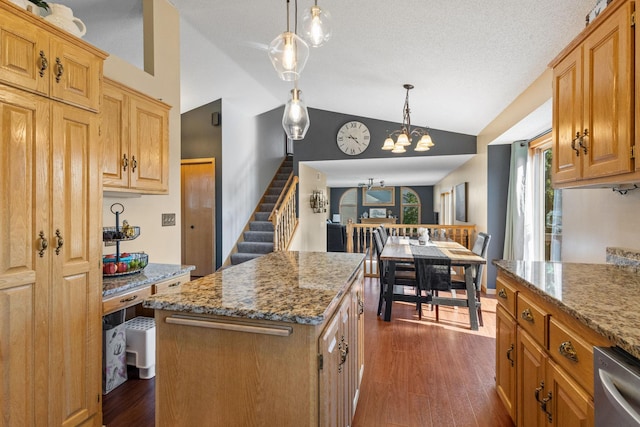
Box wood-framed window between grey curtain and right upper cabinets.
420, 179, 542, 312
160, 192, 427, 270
529, 133, 562, 261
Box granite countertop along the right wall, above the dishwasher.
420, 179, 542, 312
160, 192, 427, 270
493, 260, 640, 359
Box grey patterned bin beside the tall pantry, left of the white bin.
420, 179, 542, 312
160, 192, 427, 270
102, 309, 127, 394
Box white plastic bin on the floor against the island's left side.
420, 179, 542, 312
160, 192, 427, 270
125, 317, 156, 380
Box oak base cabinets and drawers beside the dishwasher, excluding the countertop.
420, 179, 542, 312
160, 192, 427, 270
496, 270, 611, 427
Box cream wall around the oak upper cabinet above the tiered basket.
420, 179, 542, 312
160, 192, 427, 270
103, 0, 181, 264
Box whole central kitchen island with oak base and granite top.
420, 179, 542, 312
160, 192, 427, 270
144, 252, 364, 427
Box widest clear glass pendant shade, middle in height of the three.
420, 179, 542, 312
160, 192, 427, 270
269, 31, 309, 82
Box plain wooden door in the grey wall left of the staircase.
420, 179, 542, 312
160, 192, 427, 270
180, 158, 216, 277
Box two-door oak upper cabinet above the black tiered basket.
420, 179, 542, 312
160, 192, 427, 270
101, 79, 170, 194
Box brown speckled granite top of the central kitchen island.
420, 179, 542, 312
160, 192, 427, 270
143, 251, 364, 325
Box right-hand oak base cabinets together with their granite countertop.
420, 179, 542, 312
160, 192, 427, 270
494, 260, 640, 426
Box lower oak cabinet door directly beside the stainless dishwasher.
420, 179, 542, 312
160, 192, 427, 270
545, 359, 594, 427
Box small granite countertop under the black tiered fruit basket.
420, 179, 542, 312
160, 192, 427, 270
102, 264, 195, 298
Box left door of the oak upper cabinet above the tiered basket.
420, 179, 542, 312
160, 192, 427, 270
100, 84, 131, 188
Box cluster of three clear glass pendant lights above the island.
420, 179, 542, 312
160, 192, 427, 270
269, 0, 331, 140
